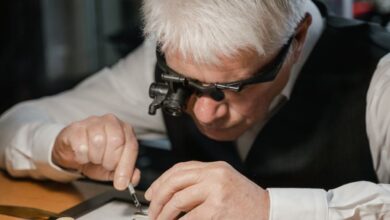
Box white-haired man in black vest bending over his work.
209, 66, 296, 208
0, 0, 390, 219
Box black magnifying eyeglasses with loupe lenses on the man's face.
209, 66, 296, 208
149, 36, 294, 116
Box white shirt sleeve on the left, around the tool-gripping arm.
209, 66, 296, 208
0, 40, 166, 181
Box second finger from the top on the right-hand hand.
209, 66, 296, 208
149, 168, 200, 219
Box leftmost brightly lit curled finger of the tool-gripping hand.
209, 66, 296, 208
69, 125, 89, 164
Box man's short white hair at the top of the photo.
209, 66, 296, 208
142, 0, 307, 64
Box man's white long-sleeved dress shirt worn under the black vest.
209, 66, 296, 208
0, 1, 390, 220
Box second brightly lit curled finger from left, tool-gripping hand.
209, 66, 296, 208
87, 123, 106, 164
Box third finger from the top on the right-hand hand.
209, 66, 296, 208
156, 185, 207, 219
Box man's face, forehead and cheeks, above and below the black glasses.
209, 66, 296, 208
166, 50, 292, 141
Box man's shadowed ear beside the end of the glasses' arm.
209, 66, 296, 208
294, 13, 312, 63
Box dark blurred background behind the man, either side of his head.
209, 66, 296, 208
0, 0, 390, 113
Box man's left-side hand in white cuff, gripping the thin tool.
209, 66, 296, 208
52, 114, 140, 190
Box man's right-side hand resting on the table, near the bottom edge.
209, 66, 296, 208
145, 161, 269, 220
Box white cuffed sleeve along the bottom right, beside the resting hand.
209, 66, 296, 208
268, 181, 390, 220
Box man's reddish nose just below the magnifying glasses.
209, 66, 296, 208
193, 96, 228, 124
